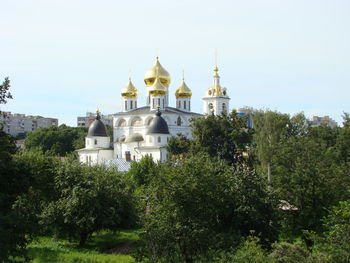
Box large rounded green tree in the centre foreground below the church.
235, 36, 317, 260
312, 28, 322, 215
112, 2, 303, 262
138, 156, 274, 262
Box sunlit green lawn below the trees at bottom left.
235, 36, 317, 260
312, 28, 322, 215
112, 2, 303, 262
18, 230, 138, 263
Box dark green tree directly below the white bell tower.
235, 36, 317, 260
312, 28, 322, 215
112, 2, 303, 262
191, 111, 252, 164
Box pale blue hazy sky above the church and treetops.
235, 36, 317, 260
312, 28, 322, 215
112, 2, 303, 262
0, 0, 350, 126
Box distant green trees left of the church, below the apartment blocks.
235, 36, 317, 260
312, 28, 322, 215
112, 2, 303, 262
25, 124, 87, 156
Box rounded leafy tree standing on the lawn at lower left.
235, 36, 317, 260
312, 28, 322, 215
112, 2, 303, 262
41, 160, 135, 246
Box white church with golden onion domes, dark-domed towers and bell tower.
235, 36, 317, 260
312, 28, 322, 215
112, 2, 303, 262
78, 57, 230, 166
